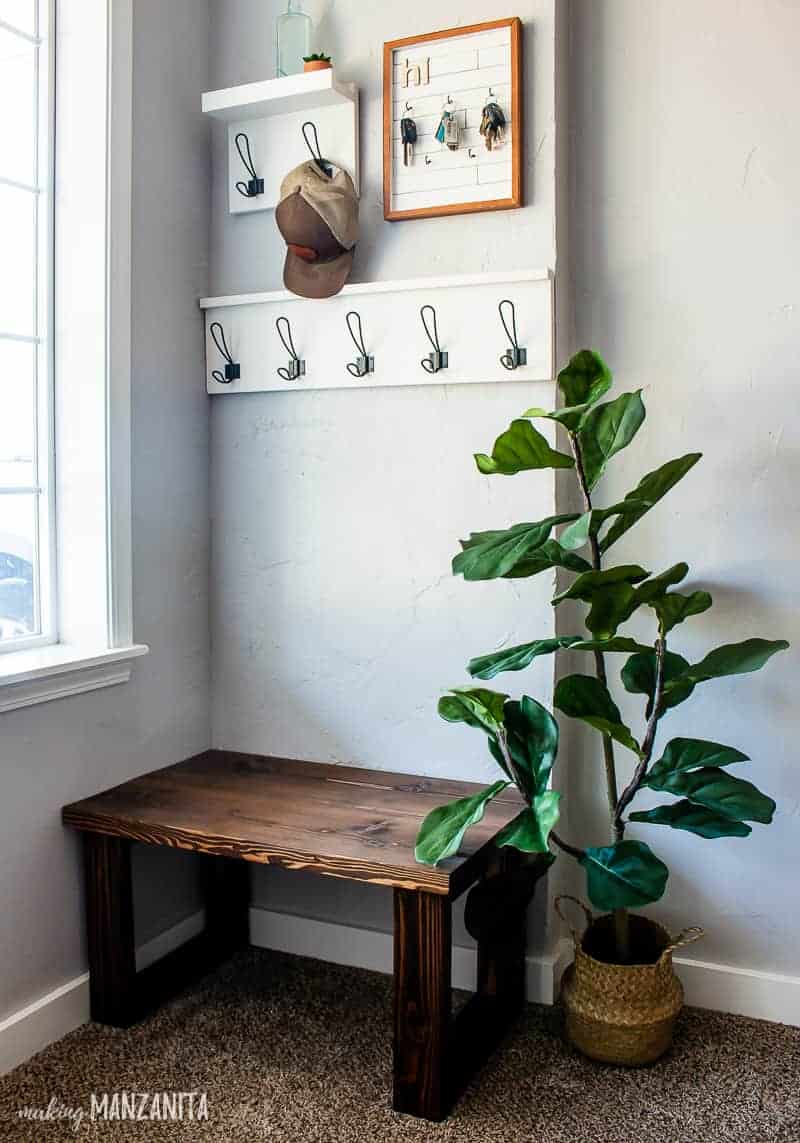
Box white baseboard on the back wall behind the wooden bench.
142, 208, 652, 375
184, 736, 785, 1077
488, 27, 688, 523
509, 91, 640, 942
250, 909, 571, 1004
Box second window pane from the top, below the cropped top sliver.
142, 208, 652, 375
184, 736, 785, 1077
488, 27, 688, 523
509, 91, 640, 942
0, 26, 37, 184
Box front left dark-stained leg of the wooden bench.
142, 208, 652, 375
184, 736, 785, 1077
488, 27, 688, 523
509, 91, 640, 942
83, 833, 136, 1028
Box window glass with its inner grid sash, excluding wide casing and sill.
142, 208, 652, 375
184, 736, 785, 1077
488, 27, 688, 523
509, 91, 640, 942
0, 0, 56, 653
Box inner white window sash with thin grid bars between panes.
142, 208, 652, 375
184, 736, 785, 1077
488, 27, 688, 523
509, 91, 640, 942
0, 0, 58, 663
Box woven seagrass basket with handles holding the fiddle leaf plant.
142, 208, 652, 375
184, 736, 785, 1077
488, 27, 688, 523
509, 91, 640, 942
555, 896, 703, 1068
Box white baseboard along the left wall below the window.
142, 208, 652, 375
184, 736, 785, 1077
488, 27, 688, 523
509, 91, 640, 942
0, 911, 205, 1076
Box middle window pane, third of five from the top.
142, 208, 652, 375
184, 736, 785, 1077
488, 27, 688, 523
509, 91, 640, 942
0, 184, 37, 334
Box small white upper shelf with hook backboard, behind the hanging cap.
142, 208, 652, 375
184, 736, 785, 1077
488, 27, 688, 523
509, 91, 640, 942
202, 67, 359, 215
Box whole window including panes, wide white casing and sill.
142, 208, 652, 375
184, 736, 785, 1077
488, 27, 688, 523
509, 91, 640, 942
0, 0, 147, 716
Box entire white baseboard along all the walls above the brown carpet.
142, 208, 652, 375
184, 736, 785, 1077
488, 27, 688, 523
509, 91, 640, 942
0, 909, 800, 1076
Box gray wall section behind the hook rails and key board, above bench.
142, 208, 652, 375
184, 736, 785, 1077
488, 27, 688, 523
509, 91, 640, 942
210, 0, 555, 938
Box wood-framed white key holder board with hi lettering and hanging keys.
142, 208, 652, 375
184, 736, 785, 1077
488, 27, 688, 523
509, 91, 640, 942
383, 16, 522, 222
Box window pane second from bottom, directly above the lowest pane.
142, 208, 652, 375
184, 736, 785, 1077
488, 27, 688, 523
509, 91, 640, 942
0, 338, 35, 488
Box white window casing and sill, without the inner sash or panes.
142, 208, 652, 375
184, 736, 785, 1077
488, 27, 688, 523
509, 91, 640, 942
0, 0, 147, 714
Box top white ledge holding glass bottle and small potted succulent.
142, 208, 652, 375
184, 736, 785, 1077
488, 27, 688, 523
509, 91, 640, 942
202, 67, 358, 123
